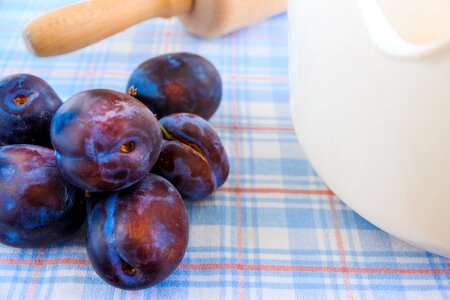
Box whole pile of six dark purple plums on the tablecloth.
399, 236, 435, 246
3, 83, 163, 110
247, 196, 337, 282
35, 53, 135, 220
0, 53, 229, 289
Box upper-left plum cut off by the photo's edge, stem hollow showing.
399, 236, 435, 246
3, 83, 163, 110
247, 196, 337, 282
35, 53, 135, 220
0, 74, 62, 147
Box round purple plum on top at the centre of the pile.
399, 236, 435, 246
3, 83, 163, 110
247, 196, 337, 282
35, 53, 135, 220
51, 89, 161, 192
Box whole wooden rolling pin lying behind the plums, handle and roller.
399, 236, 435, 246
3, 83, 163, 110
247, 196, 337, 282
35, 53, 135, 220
23, 0, 288, 56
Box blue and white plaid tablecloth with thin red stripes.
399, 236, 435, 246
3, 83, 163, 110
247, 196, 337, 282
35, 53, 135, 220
0, 0, 450, 300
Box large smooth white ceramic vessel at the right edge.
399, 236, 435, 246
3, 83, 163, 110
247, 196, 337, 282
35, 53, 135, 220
289, 0, 450, 257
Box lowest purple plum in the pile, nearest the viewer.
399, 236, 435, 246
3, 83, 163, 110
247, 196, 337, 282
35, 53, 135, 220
86, 174, 189, 290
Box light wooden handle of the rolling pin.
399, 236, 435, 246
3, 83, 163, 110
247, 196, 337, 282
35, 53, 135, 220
23, 0, 193, 57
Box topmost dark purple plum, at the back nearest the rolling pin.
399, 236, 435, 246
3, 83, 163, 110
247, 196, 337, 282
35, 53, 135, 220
127, 53, 222, 120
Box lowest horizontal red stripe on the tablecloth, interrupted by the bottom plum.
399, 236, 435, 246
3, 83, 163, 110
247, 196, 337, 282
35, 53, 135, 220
0, 258, 450, 275
